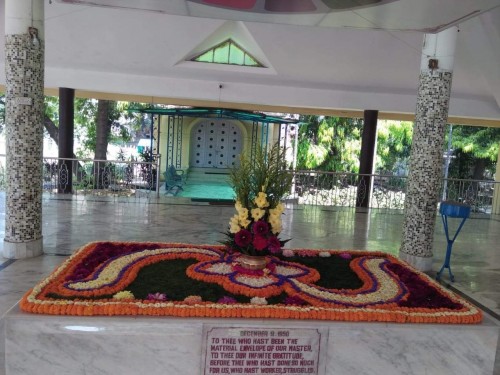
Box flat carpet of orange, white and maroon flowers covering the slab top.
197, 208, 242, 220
20, 242, 482, 324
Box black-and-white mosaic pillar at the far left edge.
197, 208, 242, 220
3, 0, 44, 258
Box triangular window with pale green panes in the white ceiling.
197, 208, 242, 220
191, 39, 264, 68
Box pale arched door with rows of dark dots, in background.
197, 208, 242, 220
190, 119, 243, 168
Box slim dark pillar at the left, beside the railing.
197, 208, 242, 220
57, 87, 75, 194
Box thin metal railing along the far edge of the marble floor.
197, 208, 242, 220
0, 155, 500, 214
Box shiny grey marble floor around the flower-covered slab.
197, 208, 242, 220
0, 193, 500, 374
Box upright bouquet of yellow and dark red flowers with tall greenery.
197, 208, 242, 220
223, 144, 293, 256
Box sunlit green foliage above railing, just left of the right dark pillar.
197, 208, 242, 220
297, 116, 363, 172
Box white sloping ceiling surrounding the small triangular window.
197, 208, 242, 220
0, 0, 500, 125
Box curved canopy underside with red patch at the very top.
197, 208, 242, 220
56, 0, 499, 32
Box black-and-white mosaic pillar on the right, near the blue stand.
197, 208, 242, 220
399, 27, 457, 271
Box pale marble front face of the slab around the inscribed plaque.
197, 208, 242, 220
5, 306, 499, 375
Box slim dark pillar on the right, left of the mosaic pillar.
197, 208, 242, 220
356, 110, 378, 207
